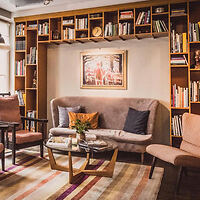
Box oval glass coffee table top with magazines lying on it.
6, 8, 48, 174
44, 136, 117, 153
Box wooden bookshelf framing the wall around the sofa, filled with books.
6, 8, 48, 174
15, 0, 200, 141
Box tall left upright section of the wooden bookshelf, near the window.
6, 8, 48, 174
14, 19, 49, 121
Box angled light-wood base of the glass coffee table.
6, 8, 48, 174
47, 148, 118, 184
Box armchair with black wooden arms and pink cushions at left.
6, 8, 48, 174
0, 95, 48, 164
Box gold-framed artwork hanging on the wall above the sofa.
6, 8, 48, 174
81, 50, 127, 89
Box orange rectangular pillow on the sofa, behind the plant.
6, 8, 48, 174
68, 112, 99, 129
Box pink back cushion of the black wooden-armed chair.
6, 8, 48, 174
0, 94, 22, 130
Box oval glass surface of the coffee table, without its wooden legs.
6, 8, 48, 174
44, 137, 118, 153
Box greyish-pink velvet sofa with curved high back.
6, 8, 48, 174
50, 96, 159, 162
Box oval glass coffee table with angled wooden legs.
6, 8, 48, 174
44, 137, 118, 183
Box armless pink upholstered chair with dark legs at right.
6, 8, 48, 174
146, 113, 200, 192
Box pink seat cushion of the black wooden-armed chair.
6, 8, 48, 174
8, 130, 42, 144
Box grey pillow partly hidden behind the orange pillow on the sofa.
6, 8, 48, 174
58, 106, 81, 128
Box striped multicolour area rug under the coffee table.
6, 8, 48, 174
0, 150, 164, 200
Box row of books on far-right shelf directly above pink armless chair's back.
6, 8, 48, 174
190, 81, 200, 102
